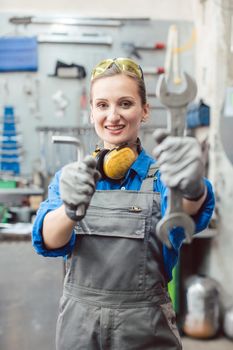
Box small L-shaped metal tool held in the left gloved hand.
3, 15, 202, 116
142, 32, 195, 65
52, 135, 86, 217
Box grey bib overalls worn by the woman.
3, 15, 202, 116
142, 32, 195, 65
56, 166, 182, 350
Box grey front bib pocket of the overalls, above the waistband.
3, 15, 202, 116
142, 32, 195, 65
72, 207, 147, 292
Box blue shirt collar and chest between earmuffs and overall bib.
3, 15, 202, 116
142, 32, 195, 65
96, 149, 155, 191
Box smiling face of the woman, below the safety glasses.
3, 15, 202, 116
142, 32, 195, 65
91, 74, 149, 149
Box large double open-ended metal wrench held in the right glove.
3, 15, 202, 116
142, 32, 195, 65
156, 73, 197, 248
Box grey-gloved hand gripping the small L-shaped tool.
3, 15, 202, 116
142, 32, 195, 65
60, 156, 100, 221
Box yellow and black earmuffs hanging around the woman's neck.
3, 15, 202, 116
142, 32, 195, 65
93, 141, 141, 180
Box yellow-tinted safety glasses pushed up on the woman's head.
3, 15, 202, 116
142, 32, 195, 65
91, 57, 143, 80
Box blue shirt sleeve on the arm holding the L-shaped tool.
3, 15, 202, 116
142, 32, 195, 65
32, 171, 75, 257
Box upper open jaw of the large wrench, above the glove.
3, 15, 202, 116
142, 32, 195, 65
156, 72, 197, 108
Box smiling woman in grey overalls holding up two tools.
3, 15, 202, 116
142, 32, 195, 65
33, 58, 214, 350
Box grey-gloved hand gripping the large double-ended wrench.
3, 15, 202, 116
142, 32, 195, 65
153, 129, 205, 200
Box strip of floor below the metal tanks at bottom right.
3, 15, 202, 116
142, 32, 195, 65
182, 337, 233, 350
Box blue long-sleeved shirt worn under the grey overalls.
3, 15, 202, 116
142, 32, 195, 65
32, 150, 215, 280
